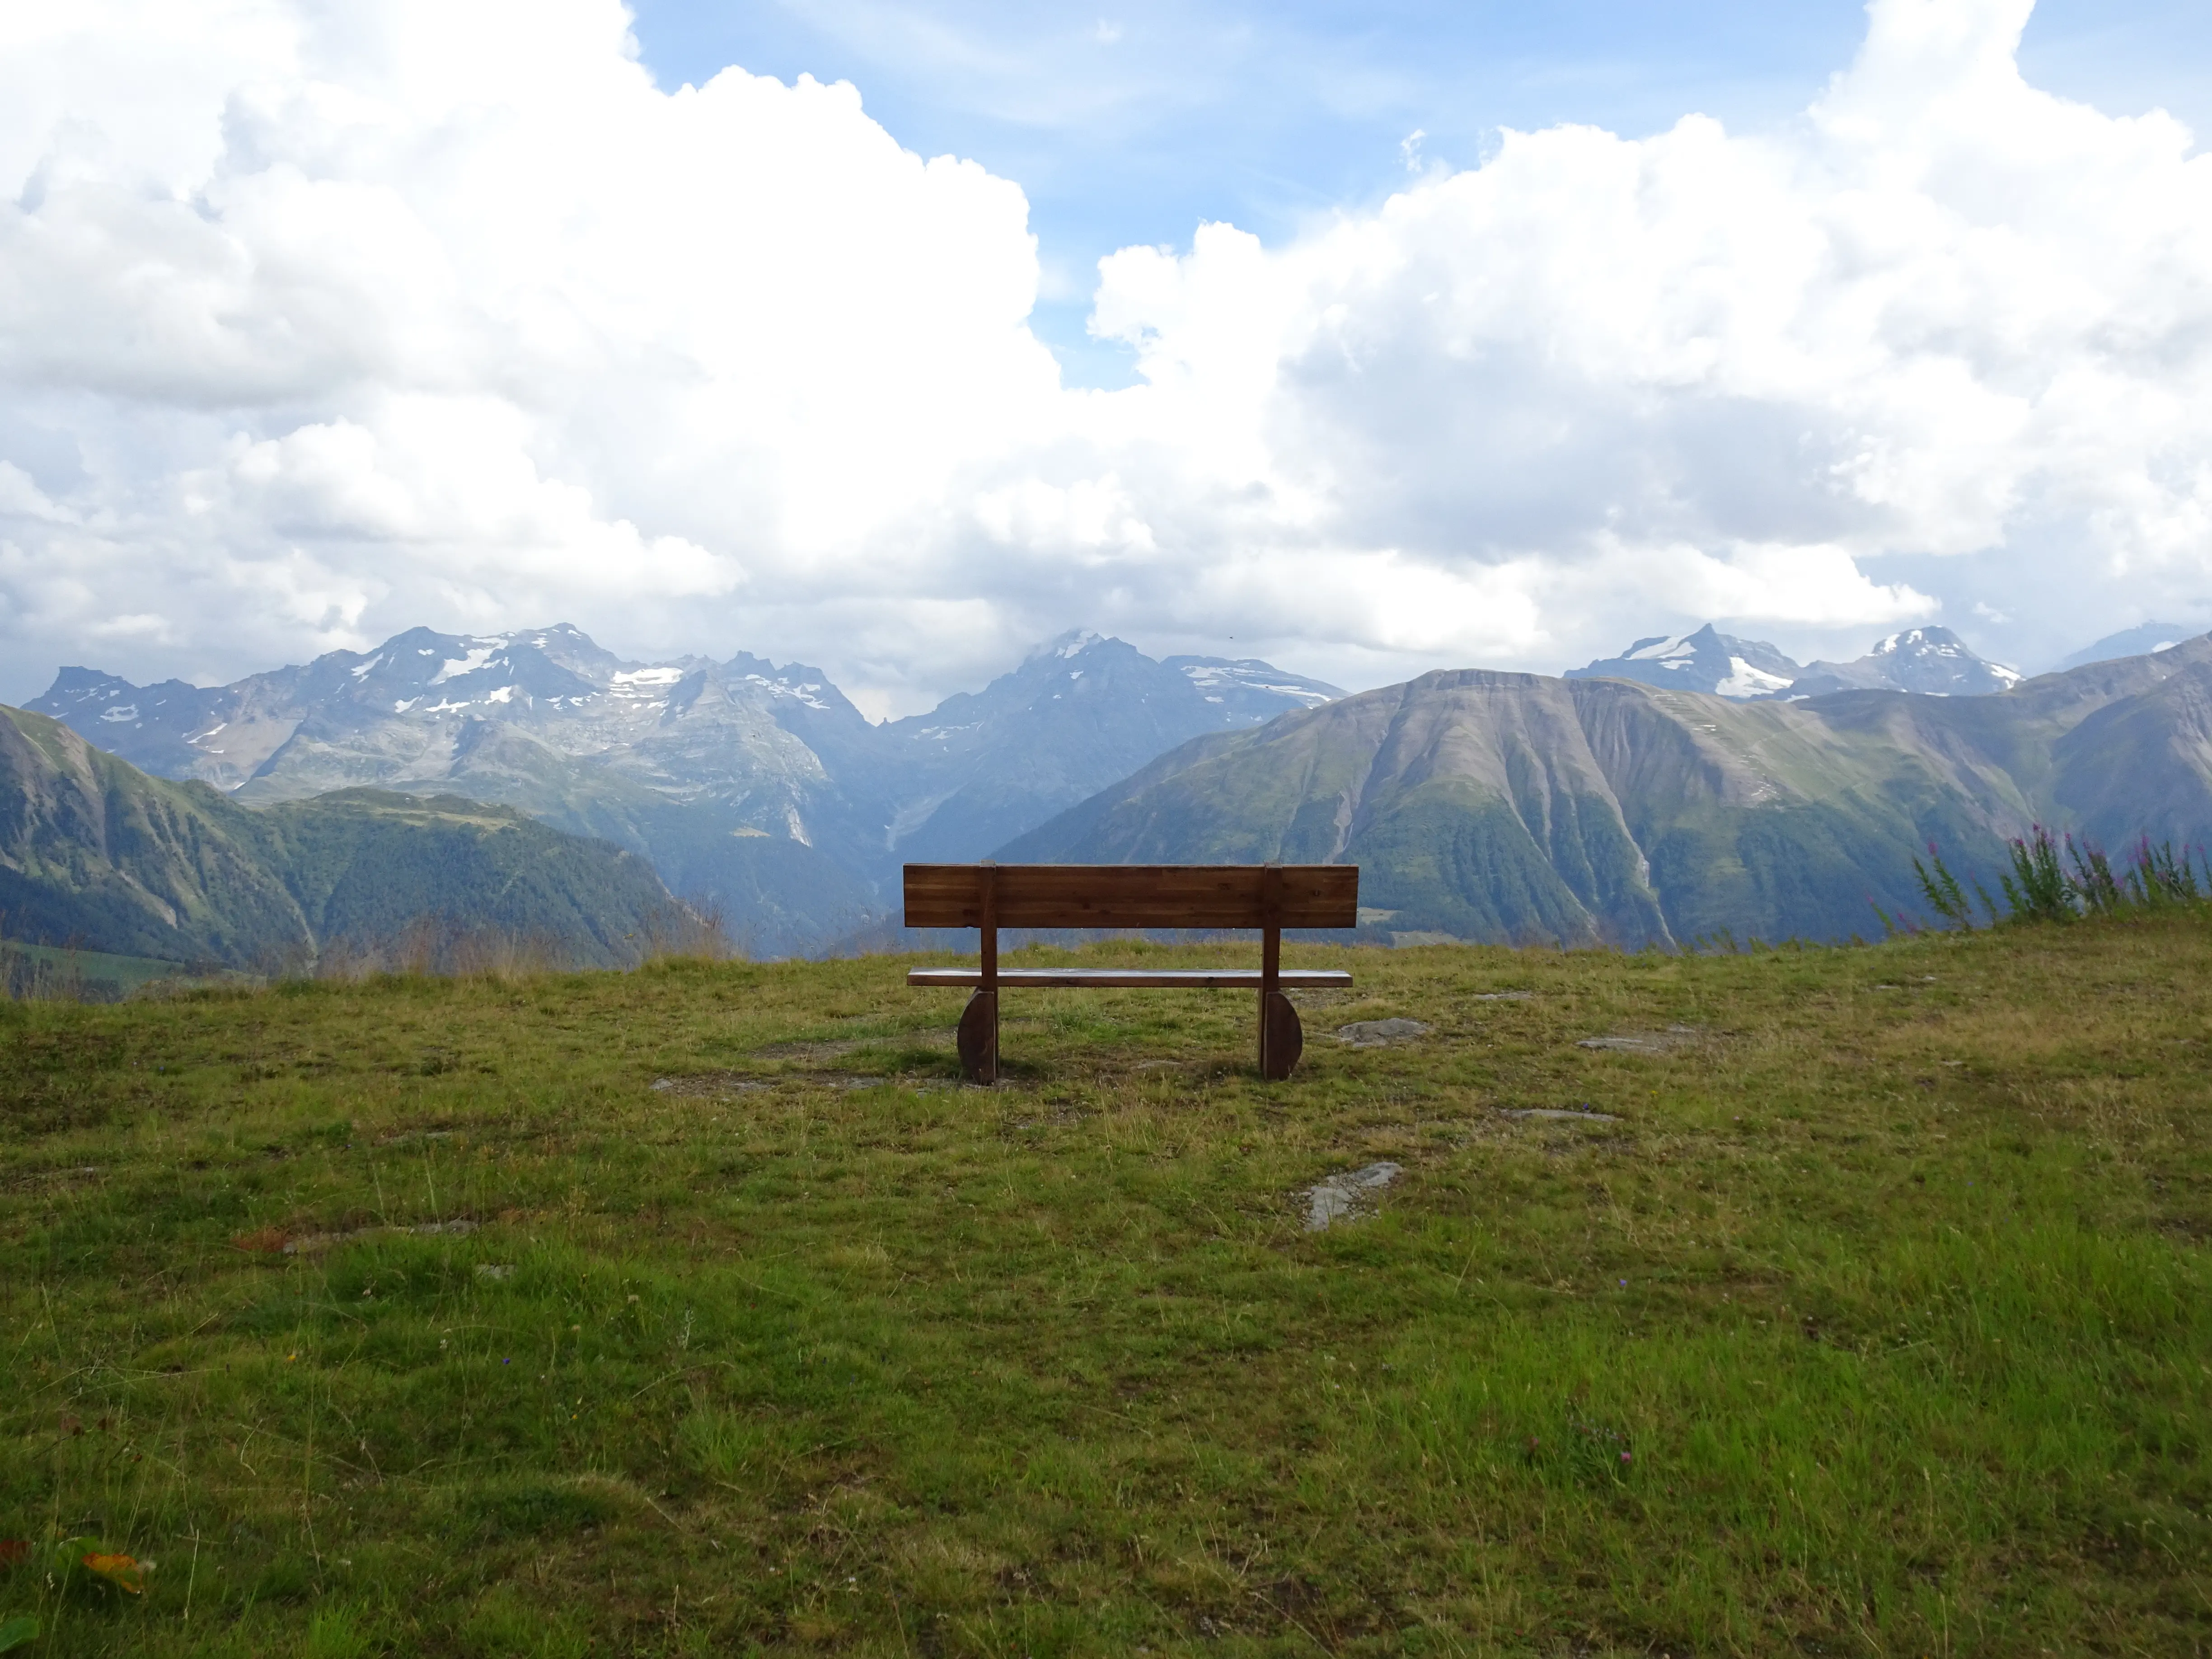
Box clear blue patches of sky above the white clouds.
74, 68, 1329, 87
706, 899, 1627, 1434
633, 0, 2212, 387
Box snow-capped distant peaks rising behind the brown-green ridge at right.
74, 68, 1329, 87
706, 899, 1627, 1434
1566, 622, 2026, 701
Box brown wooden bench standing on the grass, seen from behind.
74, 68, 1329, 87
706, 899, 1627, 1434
907, 862, 1360, 1084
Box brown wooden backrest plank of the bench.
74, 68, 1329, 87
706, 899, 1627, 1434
907, 865, 1360, 927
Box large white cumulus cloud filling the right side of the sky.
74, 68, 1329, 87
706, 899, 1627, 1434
1079, 0, 2212, 681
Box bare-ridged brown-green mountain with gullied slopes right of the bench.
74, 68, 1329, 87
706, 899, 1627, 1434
1000, 639, 2212, 945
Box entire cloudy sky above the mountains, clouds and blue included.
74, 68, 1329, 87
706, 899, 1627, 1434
0, 0, 2212, 714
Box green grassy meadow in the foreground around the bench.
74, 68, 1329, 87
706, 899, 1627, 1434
0, 916, 2212, 1657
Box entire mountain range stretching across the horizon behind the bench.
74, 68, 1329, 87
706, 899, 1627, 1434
21, 626, 2212, 960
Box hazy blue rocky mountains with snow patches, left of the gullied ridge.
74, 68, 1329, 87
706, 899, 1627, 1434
33, 626, 1340, 956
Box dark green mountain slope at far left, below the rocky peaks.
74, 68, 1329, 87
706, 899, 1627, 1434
0, 708, 668, 967
